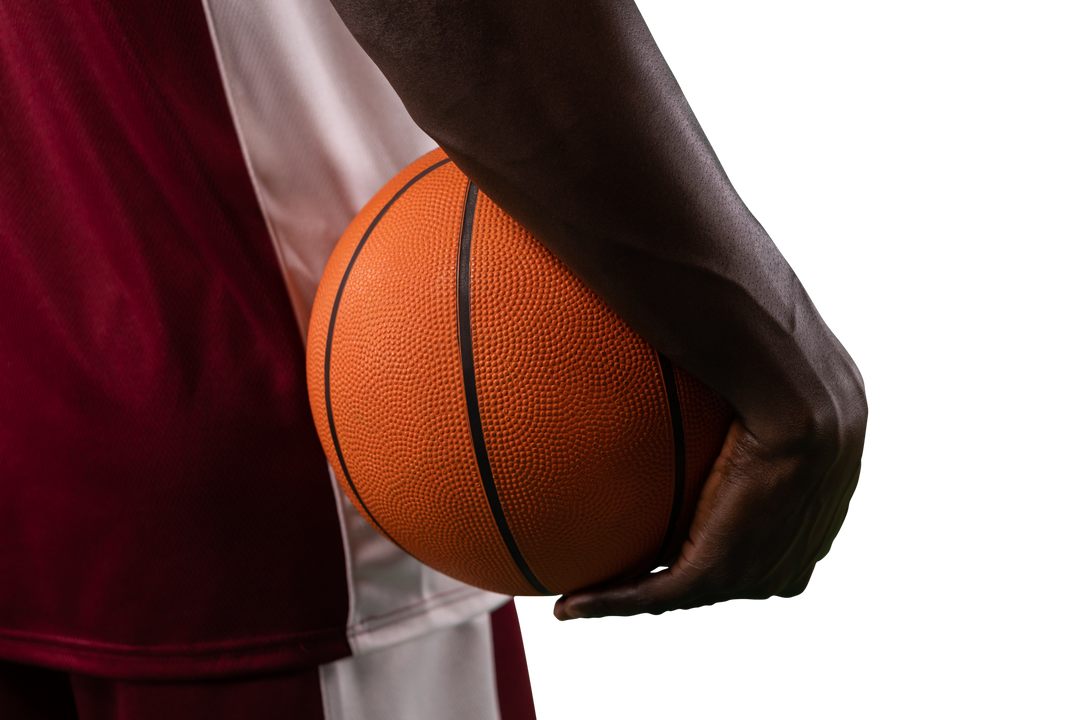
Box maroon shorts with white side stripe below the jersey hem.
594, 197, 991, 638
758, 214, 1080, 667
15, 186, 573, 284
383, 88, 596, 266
0, 601, 539, 720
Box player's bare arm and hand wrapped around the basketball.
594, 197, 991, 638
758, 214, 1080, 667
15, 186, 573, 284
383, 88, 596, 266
332, 0, 869, 622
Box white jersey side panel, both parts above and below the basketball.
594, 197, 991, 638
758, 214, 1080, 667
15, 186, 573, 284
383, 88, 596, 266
203, 0, 509, 654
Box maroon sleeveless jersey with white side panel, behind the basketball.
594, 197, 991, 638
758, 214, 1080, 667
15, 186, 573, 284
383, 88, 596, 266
0, 0, 509, 680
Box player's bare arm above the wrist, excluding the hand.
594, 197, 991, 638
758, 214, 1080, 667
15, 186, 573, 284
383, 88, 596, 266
333, 0, 865, 446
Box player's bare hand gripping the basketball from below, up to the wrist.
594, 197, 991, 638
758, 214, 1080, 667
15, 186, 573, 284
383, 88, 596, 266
551, 417, 869, 623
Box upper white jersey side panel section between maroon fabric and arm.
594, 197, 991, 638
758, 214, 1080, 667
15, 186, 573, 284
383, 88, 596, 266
203, 0, 436, 336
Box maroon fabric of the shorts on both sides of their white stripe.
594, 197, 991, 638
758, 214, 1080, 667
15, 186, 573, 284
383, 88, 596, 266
0, 601, 539, 720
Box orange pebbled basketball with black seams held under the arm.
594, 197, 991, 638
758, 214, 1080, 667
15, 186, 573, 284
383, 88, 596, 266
308, 150, 730, 598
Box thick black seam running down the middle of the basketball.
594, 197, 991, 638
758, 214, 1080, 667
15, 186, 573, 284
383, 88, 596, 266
458, 182, 554, 597
